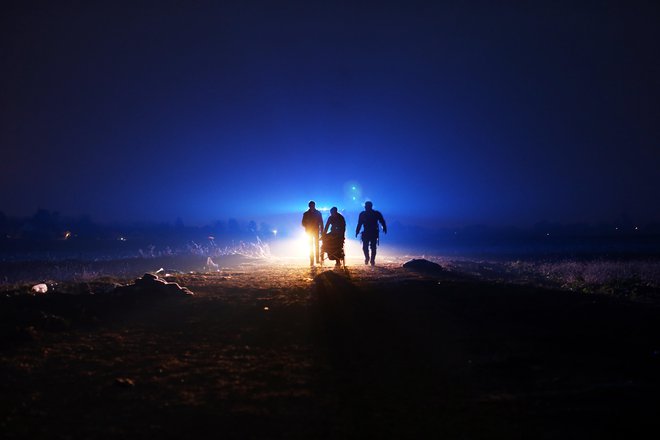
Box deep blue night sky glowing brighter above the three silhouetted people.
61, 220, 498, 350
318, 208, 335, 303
0, 1, 660, 226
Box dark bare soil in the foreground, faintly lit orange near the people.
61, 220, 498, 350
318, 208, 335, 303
0, 265, 660, 439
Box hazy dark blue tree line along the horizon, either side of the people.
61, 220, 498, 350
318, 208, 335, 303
0, 209, 660, 244
